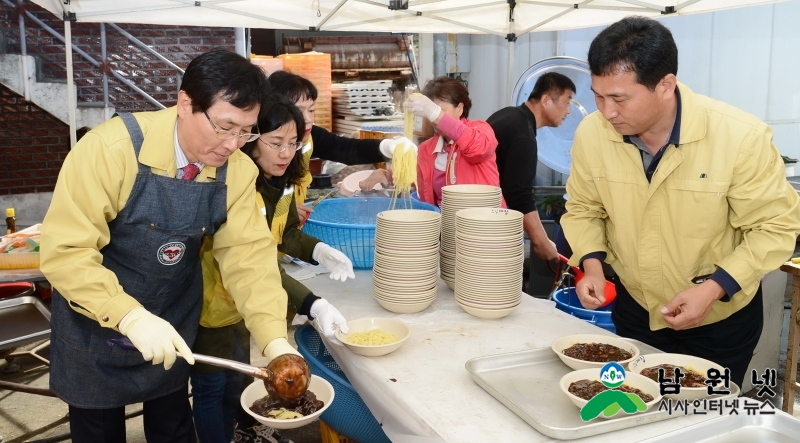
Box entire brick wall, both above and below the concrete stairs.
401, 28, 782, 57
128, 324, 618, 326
0, 1, 235, 195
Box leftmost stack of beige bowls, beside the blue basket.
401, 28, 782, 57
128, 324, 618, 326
372, 209, 442, 314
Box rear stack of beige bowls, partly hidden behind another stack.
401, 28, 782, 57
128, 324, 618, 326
439, 185, 502, 289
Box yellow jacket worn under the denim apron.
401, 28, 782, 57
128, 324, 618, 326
41, 107, 287, 349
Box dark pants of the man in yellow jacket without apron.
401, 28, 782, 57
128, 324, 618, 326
611, 280, 764, 388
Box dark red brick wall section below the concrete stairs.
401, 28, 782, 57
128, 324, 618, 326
0, 85, 69, 195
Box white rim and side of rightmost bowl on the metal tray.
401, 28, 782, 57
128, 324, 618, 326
627, 353, 734, 400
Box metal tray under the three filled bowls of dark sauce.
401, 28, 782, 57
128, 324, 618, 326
466, 340, 739, 440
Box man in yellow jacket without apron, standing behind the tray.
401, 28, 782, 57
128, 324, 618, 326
561, 17, 800, 385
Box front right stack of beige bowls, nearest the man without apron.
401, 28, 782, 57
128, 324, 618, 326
455, 208, 525, 318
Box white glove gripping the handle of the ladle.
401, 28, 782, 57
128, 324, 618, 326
119, 306, 194, 369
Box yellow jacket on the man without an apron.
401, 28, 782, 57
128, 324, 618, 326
561, 83, 800, 330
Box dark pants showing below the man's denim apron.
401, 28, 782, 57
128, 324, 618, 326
69, 386, 197, 443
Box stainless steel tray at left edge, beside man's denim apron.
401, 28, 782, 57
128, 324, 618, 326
0, 297, 50, 349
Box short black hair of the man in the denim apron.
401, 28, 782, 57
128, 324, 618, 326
180, 48, 269, 113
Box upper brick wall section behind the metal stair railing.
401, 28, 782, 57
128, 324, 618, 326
0, 1, 235, 111
